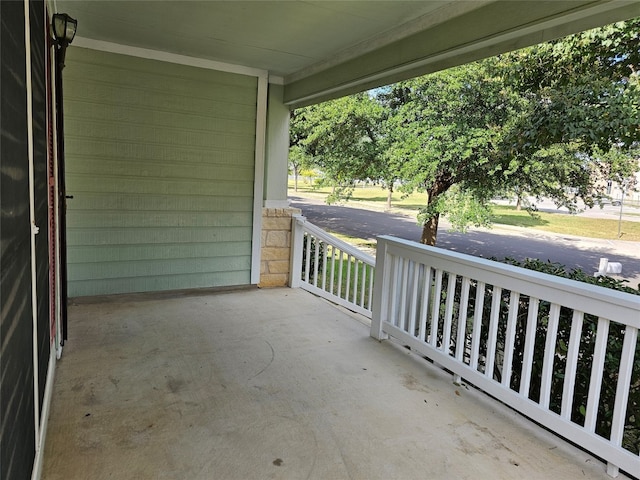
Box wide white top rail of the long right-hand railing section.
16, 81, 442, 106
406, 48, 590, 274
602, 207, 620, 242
378, 235, 640, 328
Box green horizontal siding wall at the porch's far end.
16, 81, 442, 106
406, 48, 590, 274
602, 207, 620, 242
64, 48, 257, 296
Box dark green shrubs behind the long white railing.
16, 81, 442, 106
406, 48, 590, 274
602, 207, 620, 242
415, 258, 640, 455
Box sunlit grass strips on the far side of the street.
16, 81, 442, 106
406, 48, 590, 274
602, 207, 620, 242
289, 179, 640, 242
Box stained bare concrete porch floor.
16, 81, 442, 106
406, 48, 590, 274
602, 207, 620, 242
42, 288, 620, 480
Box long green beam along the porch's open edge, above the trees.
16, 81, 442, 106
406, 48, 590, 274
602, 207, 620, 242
284, 0, 640, 108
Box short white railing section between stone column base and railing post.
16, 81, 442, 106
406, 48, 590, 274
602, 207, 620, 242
289, 215, 375, 318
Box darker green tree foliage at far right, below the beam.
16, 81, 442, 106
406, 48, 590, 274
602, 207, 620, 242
496, 19, 640, 210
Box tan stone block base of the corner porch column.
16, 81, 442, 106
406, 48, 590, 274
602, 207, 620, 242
258, 208, 300, 287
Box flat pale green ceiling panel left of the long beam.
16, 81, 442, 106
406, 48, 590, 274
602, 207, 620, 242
57, 0, 449, 76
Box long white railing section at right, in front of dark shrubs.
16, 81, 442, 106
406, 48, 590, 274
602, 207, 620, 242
371, 237, 640, 477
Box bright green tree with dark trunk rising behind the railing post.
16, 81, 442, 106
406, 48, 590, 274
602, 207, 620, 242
384, 62, 517, 245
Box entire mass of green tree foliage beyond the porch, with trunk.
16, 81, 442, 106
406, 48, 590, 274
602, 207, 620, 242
291, 19, 640, 245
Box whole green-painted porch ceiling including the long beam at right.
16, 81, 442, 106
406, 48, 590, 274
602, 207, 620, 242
56, 0, 640, 106
